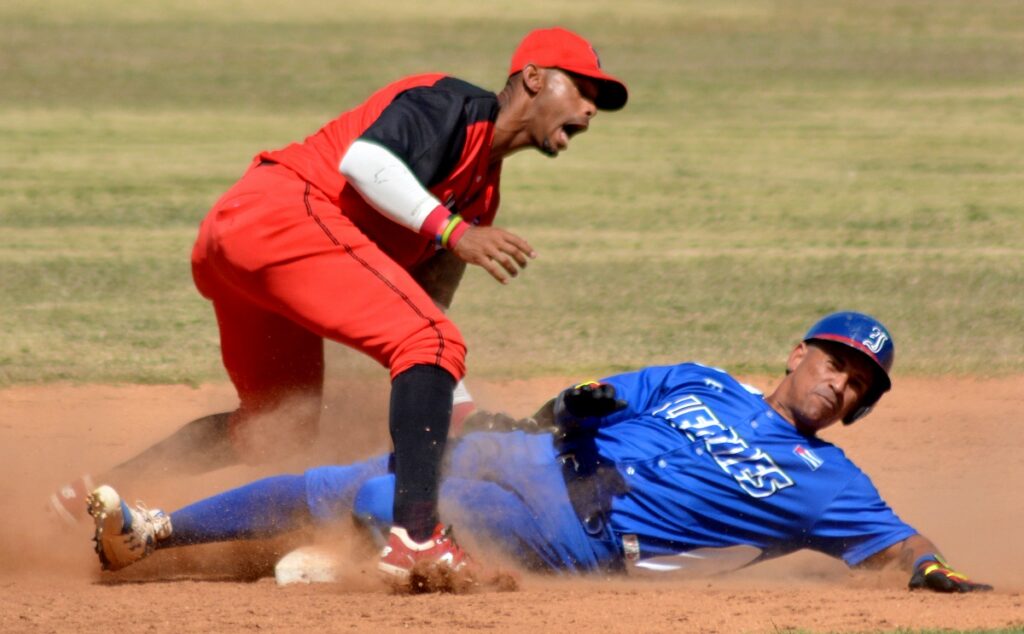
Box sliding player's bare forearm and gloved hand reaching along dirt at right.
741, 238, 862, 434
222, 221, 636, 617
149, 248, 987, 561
861, 535, 992, 592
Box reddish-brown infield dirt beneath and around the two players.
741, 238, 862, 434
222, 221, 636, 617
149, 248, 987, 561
0, 377, 1024, 634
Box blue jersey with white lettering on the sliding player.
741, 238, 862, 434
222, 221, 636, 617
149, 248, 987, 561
560, 364, 916, 568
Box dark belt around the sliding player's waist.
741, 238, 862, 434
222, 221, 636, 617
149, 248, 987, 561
557, 453, 626, 573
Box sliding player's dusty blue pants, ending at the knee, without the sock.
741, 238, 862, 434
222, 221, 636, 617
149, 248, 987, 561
305, 432, 618, 573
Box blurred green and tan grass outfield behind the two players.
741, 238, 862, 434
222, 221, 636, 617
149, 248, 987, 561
0, 0, 1024, 385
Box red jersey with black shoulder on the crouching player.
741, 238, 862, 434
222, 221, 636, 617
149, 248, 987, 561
259, 74, 502, 268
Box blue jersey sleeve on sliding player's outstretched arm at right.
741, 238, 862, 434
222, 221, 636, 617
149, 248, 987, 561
809, 473, 918, 566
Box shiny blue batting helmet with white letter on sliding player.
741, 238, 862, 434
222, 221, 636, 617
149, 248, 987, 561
804, 310, 896, 425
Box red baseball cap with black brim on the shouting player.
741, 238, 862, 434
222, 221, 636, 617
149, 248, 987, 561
509, 27, 629, 110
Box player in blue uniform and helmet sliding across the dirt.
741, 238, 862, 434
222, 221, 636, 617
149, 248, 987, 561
89, 312, 991, 592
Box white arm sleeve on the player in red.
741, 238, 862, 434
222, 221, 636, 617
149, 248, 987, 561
338, 139, 440, 231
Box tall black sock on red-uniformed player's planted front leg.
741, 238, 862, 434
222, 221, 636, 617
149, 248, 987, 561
389, 366, 455, 542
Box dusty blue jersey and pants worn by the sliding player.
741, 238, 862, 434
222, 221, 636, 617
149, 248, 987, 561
305, 364, 916, 573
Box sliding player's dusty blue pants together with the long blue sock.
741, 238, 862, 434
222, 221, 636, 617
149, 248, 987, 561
164, 431, 622, 573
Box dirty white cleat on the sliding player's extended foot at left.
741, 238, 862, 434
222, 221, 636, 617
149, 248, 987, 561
86, 484, 171, 570
